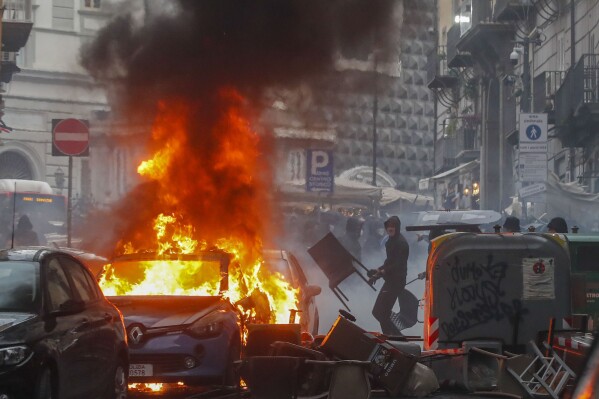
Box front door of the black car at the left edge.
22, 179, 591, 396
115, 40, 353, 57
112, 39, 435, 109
44, 256, 95, 398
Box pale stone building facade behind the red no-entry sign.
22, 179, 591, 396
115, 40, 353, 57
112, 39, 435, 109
0, 0, 113, 205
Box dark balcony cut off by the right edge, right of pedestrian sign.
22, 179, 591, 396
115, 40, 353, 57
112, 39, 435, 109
555, 54, 599, 147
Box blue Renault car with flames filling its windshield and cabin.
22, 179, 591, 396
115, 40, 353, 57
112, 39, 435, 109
100, 250, 241, 391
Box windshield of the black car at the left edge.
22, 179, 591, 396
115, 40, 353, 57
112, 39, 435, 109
0, 261, 40, 312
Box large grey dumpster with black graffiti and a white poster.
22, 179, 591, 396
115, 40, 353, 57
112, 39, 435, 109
424, 233, 571, 350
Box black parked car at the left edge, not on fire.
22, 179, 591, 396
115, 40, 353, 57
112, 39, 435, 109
0, 247, 129, 399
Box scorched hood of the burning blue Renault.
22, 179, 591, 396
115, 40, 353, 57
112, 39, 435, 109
108, 296, 232, 328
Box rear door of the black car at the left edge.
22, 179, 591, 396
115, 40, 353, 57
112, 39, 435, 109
59, 256, 120, 394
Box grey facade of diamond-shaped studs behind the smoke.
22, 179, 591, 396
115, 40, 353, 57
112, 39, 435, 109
316, 0, 435, 192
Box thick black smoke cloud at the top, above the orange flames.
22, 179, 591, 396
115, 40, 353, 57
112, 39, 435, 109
82, 0, 397, 106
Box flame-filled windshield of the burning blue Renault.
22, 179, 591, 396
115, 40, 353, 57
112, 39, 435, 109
100, 259, 221, 296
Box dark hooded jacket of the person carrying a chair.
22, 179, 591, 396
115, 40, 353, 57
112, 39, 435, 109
381, 216, 410, 286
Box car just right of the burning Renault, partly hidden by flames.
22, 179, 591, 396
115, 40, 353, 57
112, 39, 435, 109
263, 249, 321, 335
